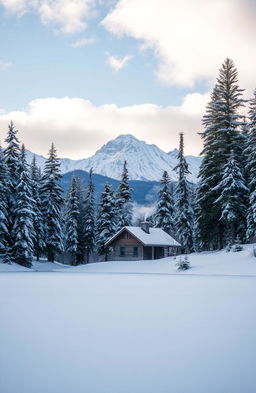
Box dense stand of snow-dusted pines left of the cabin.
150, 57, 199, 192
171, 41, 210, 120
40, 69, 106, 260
0, 123, 132, 267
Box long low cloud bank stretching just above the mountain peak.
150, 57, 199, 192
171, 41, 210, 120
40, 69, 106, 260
0, 93, 209, 159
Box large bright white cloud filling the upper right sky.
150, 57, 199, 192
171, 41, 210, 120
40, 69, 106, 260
102, 0, 256, 88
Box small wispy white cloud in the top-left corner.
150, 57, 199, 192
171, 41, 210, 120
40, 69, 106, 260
0, 0, 96, 34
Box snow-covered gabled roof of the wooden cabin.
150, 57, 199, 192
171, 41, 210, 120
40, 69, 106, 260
106, 226, 181, 246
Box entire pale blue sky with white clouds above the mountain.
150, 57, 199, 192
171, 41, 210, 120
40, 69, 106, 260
0, 0, 256, 159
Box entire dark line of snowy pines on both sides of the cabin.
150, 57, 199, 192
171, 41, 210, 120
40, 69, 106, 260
0, 59, 256, 267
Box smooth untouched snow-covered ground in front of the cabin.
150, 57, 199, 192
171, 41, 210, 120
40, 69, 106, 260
0, 246, 256, 393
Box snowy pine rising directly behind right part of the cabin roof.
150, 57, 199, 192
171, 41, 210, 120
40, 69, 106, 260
154, 171, 174, 234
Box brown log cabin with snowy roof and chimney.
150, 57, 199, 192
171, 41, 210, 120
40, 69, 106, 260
106, 221, 181, 261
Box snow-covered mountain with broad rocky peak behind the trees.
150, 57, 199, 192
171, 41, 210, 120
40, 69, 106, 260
28, 134, 202, 182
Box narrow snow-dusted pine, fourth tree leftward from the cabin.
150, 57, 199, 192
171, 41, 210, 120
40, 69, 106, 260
65, 176, 80, 265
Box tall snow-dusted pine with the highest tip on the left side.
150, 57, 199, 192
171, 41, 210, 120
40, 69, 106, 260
4, 122, 20, 261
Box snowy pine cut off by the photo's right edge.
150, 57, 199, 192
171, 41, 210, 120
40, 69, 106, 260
246, 90, 256, 240
